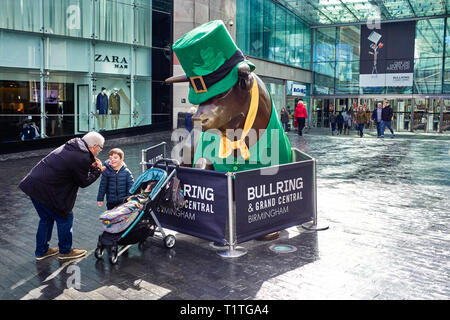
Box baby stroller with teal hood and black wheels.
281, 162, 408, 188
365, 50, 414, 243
95, 159, 184, 264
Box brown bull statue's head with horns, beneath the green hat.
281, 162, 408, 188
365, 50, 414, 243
166, 63, 257, 131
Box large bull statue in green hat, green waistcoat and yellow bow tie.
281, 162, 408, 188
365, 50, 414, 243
166, 20, 291, 172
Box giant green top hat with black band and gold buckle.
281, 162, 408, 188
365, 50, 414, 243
166, 20, 255, 104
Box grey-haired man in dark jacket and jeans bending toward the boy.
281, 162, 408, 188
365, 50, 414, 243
19, 132, 105, 260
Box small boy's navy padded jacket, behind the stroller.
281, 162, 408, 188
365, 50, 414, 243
97, 160, 134, 203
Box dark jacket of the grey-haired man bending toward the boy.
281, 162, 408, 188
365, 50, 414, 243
19, 138, 101, 218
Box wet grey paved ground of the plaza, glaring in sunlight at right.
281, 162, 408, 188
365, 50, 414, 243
0, 130, 450, 300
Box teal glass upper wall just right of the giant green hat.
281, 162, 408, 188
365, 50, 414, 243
236, 0, 311, 69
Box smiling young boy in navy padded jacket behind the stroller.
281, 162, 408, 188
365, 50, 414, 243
97, 148, 134, 210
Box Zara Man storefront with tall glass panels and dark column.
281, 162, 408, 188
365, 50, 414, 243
0, 0, 173, 142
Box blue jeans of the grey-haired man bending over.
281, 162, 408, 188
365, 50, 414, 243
31, 199, 73, 257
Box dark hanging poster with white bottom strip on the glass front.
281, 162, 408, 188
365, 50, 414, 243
359, 21, 416, 87
